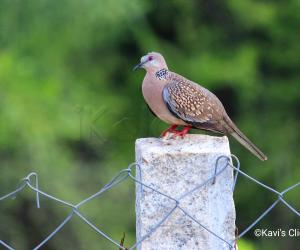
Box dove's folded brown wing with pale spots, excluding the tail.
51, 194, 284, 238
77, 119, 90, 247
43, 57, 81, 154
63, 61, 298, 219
163, 72, 224, 126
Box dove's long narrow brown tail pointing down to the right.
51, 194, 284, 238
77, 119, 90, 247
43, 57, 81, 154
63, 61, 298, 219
224, 117, 268, 161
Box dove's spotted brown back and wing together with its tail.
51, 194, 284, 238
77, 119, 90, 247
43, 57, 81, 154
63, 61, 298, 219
163, 72, 267, 161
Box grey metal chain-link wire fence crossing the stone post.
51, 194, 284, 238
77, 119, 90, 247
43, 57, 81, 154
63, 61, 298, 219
0, 155, 300, 250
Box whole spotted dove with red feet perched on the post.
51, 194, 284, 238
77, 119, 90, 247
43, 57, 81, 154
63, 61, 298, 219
134, 52, 267, 161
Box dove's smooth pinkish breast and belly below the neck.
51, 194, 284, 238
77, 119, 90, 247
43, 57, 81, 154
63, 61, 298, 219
142, 74, 187, 125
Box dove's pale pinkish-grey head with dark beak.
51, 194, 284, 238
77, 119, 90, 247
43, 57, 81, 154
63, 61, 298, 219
133, 52, 168, 72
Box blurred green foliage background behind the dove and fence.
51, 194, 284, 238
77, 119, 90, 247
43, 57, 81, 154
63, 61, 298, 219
0, 0, 300, 250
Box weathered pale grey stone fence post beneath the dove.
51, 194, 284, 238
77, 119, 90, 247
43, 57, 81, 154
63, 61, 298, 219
136, 135, 235, 250
